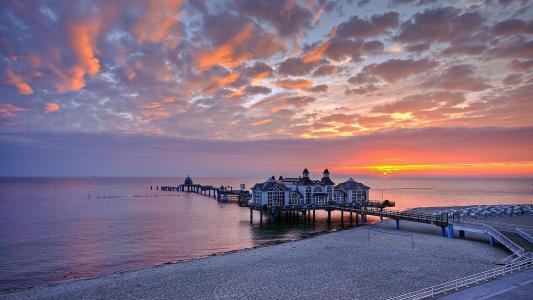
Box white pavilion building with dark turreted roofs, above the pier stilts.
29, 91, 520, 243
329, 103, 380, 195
252, 169, 370, 207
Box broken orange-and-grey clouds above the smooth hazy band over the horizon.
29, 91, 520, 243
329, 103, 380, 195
0, 0, 533, 176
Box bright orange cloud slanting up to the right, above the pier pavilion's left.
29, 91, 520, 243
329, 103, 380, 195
196, 23, 254, 70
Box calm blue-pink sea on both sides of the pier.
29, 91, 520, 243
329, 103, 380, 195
0, 177, 533, 290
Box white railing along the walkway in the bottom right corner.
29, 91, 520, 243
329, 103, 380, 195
389, 253, 533, 300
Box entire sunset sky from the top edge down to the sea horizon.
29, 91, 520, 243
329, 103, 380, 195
0, 0, 533, 177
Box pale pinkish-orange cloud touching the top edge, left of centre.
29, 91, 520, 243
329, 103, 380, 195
134, 0, 182, 48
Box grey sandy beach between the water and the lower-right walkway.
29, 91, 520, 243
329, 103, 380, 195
0, 221, 508, 299
